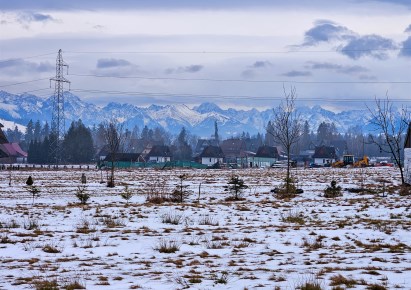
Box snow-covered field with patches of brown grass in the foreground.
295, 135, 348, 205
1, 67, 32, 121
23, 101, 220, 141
0, 168, 411, 289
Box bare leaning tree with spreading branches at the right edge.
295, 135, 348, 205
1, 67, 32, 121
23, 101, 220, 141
367, 95, 410, 184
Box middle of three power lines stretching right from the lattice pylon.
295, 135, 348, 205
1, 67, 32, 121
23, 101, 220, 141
70, 74, 411, 84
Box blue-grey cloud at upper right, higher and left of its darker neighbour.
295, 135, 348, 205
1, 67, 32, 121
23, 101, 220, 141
302, 20, 354, 46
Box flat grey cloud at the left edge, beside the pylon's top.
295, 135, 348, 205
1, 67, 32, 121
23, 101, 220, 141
0, 59, 55, 75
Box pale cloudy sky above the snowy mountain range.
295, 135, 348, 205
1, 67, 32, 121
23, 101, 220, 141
0, 0, 411, 110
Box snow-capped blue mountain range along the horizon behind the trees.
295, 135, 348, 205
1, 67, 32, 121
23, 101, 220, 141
0, 91, 370, 137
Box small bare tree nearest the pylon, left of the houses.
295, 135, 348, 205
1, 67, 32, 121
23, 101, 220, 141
103, 119, 126, 187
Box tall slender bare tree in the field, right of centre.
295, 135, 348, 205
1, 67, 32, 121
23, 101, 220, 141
267, 87, 303, 195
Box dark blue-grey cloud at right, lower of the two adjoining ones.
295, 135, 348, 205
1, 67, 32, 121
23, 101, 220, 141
339, 34, 397, 60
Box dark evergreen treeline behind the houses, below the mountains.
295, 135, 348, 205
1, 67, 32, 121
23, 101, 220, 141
5, 120, 394, 164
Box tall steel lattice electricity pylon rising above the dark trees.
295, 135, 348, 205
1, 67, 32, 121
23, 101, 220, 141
50, 49, 70, 165
